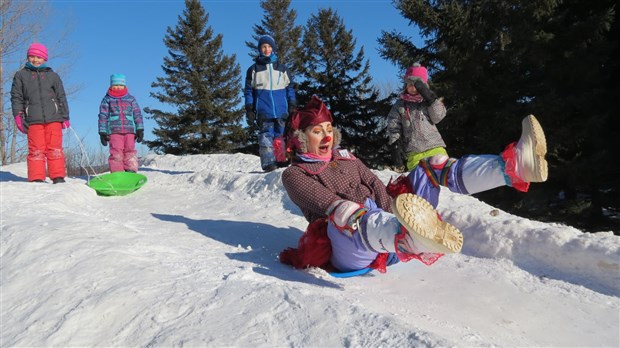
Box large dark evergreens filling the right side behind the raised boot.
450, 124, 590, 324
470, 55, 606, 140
379, 0, 620, 234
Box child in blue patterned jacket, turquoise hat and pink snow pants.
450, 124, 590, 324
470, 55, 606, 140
99, 74, 144, 173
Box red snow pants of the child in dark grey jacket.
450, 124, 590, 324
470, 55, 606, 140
27, 122, 67, 181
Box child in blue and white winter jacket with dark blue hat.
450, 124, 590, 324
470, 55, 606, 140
244, 35, 297, 172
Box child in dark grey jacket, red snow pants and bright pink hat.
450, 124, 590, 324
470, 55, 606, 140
11, 43, 70, 184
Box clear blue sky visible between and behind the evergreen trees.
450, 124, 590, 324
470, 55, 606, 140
35, 0, 421, 148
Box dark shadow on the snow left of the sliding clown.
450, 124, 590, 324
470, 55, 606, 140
152, 213, 341, 288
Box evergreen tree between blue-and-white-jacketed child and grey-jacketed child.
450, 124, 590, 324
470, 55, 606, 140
297, 9, 390, 167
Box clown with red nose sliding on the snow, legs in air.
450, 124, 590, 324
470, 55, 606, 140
280, 97, 547, 272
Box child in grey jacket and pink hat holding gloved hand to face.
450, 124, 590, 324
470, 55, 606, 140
387, 63, 448, 171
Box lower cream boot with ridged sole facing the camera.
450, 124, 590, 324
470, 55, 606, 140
392, 193, 463, 254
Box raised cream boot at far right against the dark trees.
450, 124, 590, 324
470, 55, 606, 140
515, 115, 548, 182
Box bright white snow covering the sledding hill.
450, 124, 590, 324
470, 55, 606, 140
0, 154, 620, 347
